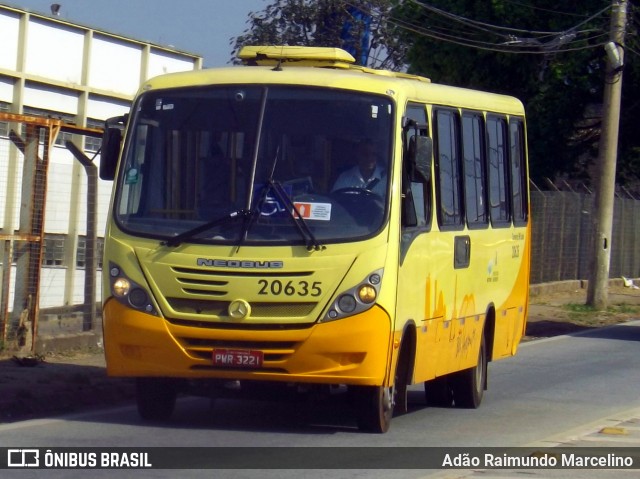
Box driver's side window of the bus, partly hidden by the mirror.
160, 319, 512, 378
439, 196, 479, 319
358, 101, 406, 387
402, 103, 431, 227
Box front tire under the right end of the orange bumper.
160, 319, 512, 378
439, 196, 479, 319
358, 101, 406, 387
355, 386, 393, 433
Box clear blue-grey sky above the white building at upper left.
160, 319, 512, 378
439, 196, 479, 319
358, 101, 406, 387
0, 0, 273, 67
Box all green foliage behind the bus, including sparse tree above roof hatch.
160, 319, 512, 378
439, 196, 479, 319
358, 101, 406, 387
231, 0, 640, 188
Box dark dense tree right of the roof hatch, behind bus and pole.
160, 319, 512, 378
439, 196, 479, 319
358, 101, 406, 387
392, 0, 640, 190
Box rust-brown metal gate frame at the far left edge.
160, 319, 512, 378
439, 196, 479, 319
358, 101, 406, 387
0, 113, 102, 351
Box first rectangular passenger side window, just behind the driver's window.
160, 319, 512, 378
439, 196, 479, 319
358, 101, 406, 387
434, 108, 463, 229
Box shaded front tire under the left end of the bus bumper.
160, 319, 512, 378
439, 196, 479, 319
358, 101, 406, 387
136, 378, 178, 421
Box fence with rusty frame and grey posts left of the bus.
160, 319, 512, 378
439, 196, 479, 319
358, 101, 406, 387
0, 112, 101, 351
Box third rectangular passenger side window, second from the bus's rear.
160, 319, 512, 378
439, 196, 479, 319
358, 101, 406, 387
487, 115, 511, 226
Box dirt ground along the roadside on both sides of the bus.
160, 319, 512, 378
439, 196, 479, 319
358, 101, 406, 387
0, 287, 640, 423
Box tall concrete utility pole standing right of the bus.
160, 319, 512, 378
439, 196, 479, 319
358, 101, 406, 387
587, 0, 627, 310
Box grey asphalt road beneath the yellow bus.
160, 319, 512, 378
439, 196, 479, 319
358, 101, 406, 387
0, 321, 640, 478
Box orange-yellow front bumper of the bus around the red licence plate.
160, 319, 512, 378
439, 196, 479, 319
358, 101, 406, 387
103, 299, 393, 386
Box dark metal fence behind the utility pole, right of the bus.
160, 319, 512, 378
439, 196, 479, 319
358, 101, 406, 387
531, 191, 640, 284
